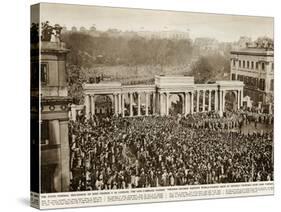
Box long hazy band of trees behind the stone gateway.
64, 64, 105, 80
62, 32, 193, 67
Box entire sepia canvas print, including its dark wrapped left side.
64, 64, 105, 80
30, 3, 274, 209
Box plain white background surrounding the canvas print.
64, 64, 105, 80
0, 0, 281, 212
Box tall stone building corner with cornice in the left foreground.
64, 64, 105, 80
38, 39, 71, 193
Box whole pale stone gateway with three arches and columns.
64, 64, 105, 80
83, 75, 244, 117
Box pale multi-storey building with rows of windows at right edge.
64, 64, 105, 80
231, 46, 274, 106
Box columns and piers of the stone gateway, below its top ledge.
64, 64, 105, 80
84, 88, 243, 117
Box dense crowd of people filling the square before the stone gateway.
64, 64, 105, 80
69, 112, 273, 191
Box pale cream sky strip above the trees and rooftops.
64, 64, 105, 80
40, 3, 274, 42
